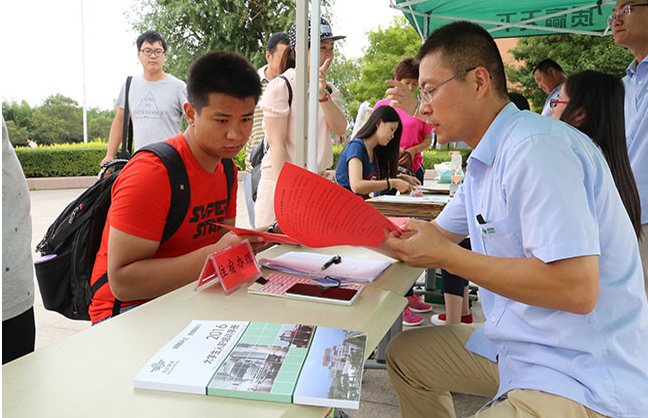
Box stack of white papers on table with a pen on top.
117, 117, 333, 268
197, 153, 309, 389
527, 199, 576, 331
259, 251, 392, 282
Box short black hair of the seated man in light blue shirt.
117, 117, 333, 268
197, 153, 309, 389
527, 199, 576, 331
416, 21, 508, 97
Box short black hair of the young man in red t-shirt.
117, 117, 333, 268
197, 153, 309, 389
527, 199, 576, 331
187, 51, 261, 113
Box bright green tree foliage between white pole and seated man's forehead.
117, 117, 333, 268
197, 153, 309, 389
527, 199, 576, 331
336, 17, 421, 127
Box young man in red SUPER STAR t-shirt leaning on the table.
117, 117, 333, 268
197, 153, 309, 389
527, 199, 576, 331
89, 51, 261, 323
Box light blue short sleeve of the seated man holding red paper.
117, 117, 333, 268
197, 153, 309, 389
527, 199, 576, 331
502, 135, 600, 263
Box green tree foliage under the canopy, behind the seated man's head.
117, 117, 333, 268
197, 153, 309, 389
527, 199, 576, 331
506, 35, 633, 109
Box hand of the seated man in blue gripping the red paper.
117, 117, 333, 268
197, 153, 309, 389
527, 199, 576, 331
384, 219, 450, 268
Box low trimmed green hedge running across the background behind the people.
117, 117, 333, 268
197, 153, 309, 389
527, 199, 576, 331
16, 142, 471, 177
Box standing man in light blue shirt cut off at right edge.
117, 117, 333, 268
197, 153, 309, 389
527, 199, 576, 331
608, 0, 648, 294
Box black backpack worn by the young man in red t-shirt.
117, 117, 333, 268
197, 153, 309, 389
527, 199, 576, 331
35, 142, 234, 320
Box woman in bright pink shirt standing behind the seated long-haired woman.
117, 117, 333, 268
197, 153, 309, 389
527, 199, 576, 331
374, 57, 432, 184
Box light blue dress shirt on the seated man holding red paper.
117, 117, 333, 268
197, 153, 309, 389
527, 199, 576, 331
436, 103, 648, 417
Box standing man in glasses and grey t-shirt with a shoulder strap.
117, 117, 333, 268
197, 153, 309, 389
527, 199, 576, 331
101, 30, 187, 164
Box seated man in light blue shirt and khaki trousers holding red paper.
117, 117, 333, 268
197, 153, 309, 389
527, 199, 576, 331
385, 22, 648, 418
